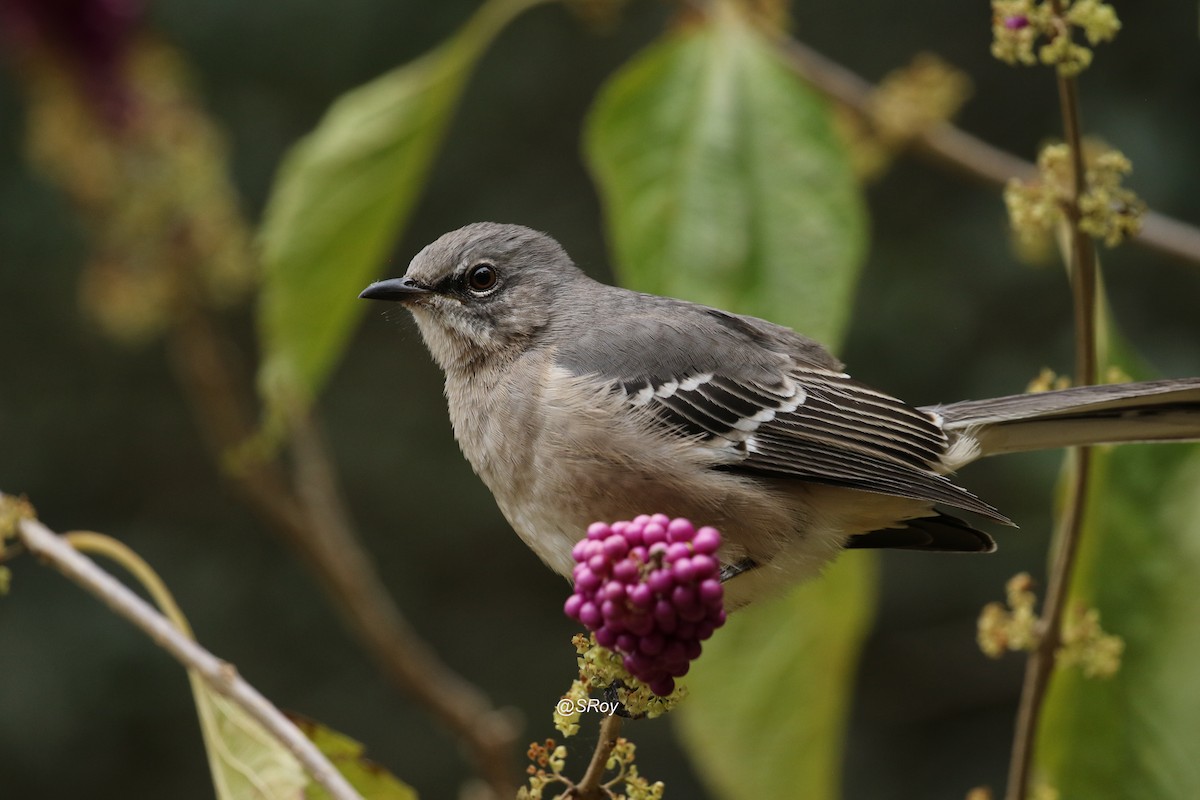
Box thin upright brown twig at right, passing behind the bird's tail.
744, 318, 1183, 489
1006, 21, 1097, 800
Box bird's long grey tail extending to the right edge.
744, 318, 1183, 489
923, 378, 1200, 467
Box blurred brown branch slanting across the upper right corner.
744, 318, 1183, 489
780, 37, 1200, 265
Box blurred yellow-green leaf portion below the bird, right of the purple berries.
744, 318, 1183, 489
674, 553, 876, 800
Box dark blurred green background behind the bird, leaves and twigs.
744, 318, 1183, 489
0, 0, 1200, 799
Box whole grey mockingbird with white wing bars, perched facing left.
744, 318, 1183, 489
361, 223, 1200, 608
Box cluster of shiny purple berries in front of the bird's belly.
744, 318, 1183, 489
563, 513, 725, 697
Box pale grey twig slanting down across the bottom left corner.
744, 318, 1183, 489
9, 495, 362, 800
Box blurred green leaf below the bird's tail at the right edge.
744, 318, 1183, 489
1037, 445, 1200, 800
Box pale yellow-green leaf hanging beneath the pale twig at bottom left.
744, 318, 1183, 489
188, 670, 308, 800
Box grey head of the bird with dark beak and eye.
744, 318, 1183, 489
359, 222, 586, 372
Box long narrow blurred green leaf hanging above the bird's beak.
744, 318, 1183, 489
258, 0, 541, 420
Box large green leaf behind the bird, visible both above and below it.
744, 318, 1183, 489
587, 2, 874, 800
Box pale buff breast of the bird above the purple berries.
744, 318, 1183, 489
446, 363, 780, 575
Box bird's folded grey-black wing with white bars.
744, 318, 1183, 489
557, 306, 1009, 523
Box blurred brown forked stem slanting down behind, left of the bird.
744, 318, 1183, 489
170, 284, 517, 798
